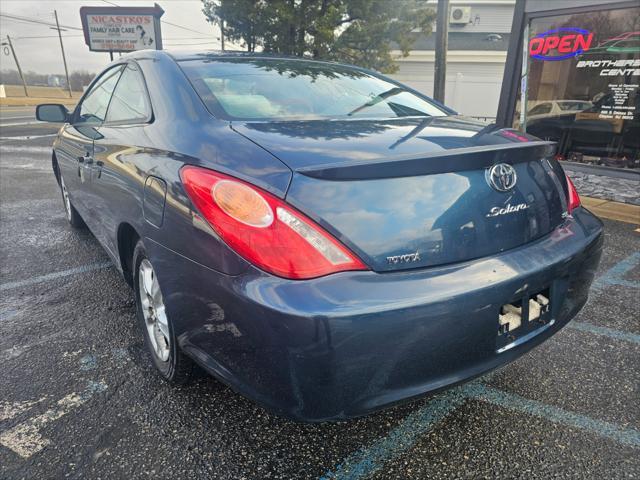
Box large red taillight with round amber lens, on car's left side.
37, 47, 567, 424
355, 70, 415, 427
180, 166, 367, 279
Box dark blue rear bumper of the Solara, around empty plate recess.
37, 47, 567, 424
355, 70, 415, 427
146, 208, 602, 421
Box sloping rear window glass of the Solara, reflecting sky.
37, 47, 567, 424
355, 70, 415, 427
175, 58, 447, 120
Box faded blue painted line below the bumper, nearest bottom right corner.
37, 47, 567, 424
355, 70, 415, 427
464, 384, 640, 448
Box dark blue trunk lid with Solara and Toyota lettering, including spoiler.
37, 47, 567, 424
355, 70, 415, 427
233, 117, 566, 272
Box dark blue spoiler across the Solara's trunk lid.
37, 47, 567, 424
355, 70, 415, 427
296, 140, 556, 181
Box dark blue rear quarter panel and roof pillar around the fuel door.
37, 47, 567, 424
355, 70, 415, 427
90, 55, 291, 275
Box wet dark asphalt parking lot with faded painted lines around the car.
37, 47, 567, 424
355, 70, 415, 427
0, 108, 640, 479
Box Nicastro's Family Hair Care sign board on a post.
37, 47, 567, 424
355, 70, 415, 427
80, 3, 164, 52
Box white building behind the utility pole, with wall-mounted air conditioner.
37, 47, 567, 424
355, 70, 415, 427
391, 0, 516, 118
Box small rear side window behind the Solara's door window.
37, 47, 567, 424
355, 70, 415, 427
106, 64, 151, 123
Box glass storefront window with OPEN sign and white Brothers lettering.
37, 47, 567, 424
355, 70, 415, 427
513, 7, 640, 169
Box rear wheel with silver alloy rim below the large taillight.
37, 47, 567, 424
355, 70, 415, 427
132, 241, 195, 383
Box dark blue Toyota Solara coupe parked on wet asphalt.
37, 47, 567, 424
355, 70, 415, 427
37, 51, 603, 421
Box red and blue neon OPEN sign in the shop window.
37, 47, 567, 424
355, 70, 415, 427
529, 28, 593, 60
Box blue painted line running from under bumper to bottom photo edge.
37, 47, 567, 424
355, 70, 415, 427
321, 387, 467, 480
